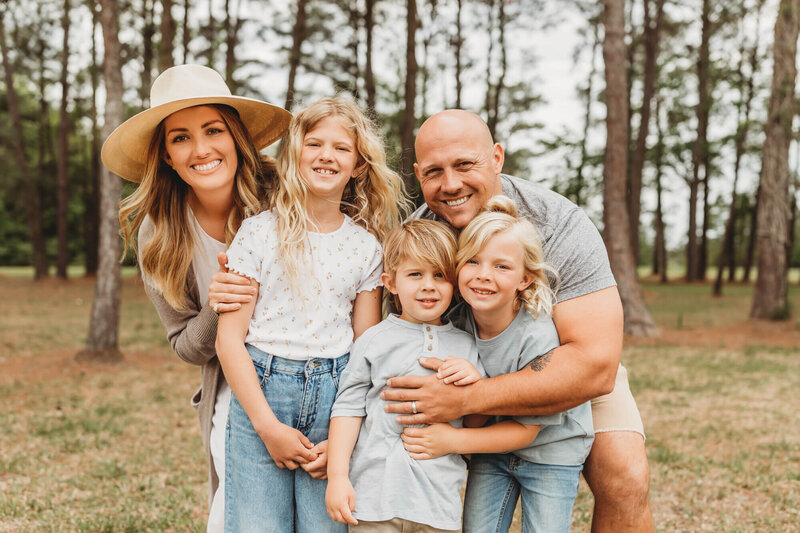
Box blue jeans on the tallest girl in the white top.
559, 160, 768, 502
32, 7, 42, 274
225, 345, 349, 533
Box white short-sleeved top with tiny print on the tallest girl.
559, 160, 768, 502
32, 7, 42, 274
227, 211, 383, 361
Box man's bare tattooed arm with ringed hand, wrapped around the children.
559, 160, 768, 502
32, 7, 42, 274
381, 287, 622, 424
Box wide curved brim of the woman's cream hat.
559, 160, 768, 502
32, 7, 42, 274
100, 96, 292, 183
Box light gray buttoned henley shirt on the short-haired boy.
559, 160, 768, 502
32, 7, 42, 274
331, 315, 478, 530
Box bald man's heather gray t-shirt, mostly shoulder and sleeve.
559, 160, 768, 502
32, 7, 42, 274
410, 174, 616, 302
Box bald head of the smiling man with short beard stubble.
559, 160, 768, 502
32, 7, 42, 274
414, 109, 504, 228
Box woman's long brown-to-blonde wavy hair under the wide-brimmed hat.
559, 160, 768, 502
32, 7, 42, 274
119, 104, 275, 309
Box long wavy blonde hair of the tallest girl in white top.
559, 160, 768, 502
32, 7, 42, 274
276, 97, 411, 285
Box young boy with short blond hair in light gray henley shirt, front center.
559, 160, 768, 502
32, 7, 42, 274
325, 220, 480, 531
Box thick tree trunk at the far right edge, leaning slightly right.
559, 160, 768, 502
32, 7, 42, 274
750, 0, 800, 320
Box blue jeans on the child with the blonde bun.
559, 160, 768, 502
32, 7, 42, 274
464, 453, 583, 533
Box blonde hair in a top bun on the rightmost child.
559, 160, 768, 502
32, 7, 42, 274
456, 195, 558, 318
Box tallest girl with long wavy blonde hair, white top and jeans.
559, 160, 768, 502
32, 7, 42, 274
217, 98, 408, 532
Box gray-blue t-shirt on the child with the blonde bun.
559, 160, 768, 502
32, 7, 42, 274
448, 304, 594, 466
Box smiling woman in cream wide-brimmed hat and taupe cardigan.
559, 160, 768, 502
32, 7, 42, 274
102, 65, 291, 531
